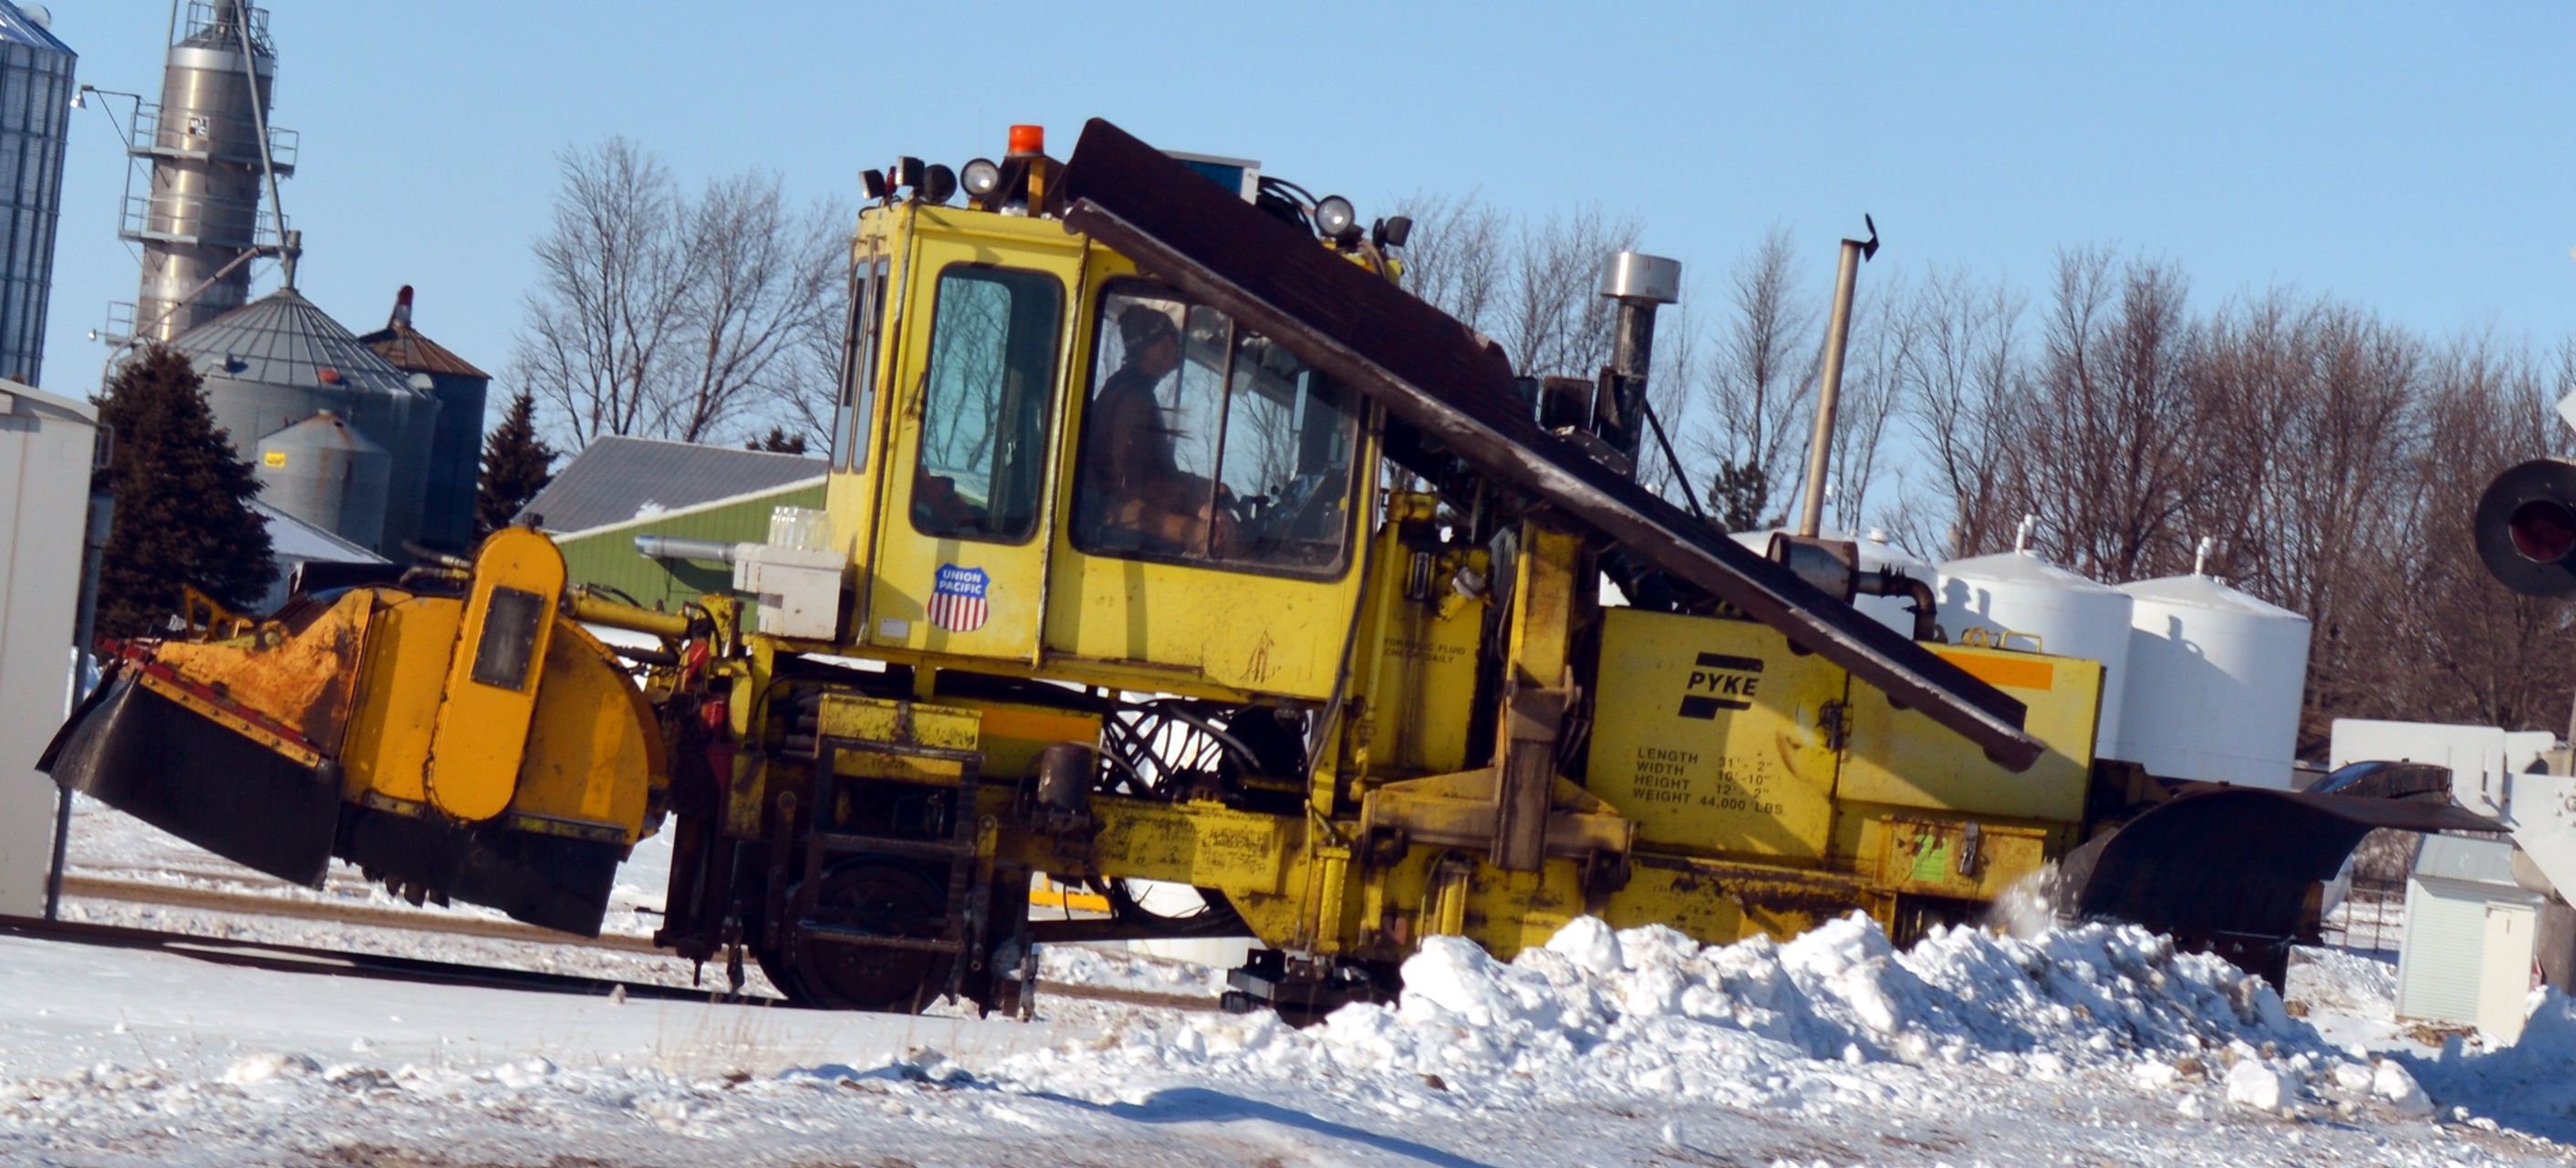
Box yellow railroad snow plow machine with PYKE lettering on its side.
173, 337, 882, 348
30, 121, 2462, 1011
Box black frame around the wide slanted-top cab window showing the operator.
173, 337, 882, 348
1061, 276, 1368, 583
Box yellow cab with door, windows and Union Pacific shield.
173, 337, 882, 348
829, 203, 1376, 699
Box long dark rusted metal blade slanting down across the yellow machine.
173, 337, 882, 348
1064, 119, 2042, 768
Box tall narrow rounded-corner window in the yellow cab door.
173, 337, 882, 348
912, 266, 1064, 544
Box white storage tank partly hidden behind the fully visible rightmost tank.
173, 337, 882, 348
1937, 552, 2130, 758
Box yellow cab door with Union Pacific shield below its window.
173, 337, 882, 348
860, 209, 1079, 662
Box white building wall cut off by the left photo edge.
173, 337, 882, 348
0, 381, 98, 915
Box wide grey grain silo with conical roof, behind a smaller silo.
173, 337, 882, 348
170, 282, 438, 562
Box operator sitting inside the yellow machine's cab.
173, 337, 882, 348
1076, 304, 1234, 555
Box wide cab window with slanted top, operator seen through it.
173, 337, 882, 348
1072, 281, 1360, 575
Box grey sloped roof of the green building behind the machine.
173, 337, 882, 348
520, 436, 827, 531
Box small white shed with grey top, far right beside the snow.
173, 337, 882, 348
2398, 835, 2542, 1042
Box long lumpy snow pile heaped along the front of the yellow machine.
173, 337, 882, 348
997, 912, 2342, 1111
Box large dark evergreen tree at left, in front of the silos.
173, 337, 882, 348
98, 346, 278, 637
